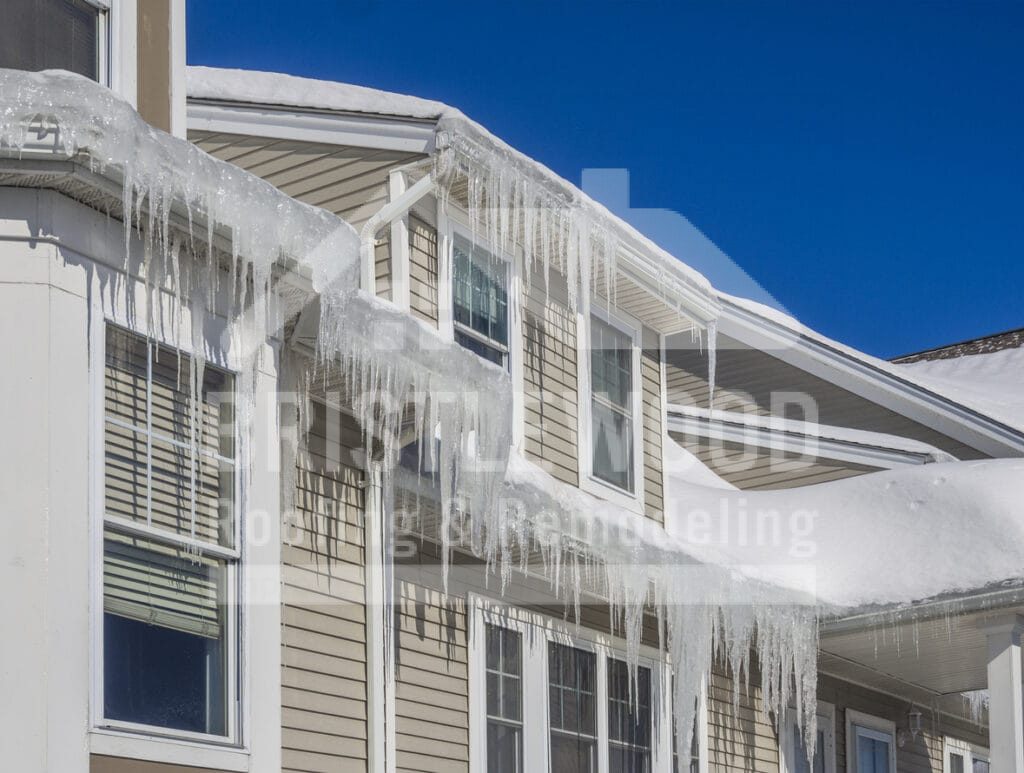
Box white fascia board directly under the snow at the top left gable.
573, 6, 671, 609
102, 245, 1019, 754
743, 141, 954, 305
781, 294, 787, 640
187, 99, 435, 154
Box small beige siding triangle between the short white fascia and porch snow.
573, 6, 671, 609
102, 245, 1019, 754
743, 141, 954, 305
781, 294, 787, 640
670, 432, 878, 489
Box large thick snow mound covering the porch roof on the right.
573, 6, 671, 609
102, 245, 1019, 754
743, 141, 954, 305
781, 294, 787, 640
666, 460, 1024, 609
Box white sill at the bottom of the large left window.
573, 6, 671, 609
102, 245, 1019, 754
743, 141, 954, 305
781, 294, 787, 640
89, 728, 249, 773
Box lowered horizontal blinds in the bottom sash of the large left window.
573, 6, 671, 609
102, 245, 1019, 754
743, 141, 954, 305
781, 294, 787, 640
103, 530, 225, 639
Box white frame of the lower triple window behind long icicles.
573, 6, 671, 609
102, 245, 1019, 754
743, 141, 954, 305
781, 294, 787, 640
467, 594, 708, 773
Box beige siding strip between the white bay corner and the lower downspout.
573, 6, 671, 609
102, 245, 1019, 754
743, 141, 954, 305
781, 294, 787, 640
282, 407, 367, 771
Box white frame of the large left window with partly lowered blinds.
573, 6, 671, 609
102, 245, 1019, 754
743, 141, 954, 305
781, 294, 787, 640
89, 304, 248, 757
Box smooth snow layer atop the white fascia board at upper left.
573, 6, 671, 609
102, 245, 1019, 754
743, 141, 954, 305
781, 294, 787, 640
185, 67, 462, 119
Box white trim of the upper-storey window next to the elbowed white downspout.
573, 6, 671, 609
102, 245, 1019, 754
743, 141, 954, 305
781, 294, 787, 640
437, 202, 526, 453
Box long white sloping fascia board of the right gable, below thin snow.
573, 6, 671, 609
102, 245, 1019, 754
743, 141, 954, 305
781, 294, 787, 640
718, 299, 1024, 458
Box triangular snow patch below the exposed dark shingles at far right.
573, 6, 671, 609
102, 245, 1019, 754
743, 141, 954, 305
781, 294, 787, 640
895, 348, 1024, 431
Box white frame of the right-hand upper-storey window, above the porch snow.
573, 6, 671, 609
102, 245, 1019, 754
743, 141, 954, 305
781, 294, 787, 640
577, 304, 644, 514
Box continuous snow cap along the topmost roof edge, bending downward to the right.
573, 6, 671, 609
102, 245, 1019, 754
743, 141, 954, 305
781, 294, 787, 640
186, 67, 713, 303
